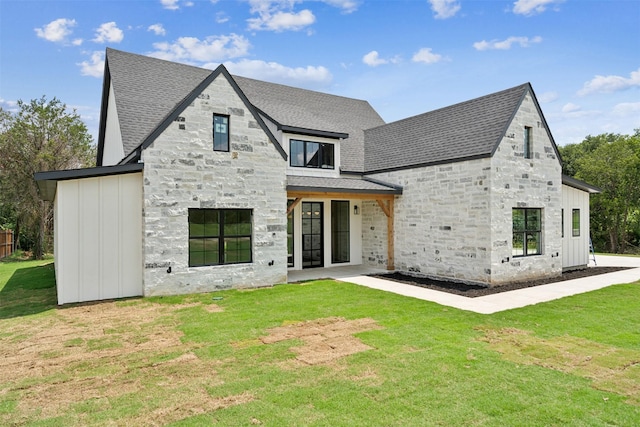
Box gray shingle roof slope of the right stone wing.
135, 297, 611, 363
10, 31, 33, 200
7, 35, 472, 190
365, 83, 533, 172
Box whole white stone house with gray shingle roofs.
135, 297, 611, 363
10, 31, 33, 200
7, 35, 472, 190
36, 49, 597, 304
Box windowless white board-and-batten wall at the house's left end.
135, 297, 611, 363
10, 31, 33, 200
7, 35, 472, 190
54, 173, 143, 304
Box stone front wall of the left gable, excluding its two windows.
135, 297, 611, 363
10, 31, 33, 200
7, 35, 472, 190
142, 74, 287, 295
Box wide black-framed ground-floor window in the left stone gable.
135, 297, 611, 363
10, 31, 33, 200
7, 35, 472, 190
189, 209, 253, 267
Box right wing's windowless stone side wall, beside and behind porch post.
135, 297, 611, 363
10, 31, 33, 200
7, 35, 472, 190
362, 159, 491, 283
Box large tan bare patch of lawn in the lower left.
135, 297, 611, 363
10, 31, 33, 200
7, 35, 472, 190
0, 301, 242, 425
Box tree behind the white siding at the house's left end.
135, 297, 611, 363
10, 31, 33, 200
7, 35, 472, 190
0, 97, 95, 258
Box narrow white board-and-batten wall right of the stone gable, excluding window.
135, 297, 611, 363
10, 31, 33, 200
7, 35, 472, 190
562, 185, 589, 270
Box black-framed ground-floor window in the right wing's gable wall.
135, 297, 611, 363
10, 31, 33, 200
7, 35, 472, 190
512, 208, 542, 257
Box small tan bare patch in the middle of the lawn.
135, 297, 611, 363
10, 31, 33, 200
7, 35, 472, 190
260, 317, 382, 365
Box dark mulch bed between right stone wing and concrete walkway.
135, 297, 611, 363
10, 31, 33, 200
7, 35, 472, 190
372, 267, 628, 298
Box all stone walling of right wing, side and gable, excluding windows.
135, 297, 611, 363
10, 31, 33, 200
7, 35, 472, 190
362, 91, 562, 286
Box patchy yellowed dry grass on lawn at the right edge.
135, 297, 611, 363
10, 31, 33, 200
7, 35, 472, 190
479, 328, 640, 406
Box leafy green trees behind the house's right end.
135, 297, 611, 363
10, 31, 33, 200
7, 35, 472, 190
560, 131, 640, 253
